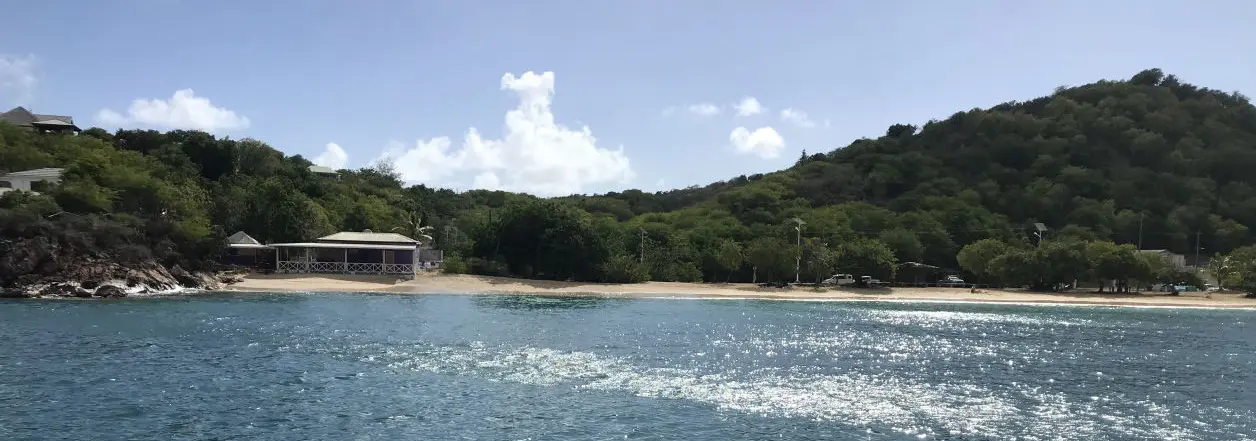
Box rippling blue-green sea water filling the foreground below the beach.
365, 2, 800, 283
0, 294, 1256, 440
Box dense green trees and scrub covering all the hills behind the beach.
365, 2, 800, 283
7, 69, 1256, 294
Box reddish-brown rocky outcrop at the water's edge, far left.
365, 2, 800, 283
0, 260, 239, 299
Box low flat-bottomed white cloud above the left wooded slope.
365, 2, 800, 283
95, 89, 249, 132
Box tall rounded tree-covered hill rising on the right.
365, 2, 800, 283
571, 69, 1256, 257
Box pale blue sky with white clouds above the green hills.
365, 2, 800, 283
0, 0, 1256, 196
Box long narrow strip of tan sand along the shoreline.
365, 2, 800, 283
227, 274, 1256, 309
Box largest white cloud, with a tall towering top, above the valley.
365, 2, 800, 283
384, 72, 636, 196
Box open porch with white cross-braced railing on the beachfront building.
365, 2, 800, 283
270, 242, 416, 278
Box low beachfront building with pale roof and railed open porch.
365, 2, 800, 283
268, 230, 421, 278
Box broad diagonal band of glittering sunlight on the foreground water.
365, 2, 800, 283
344, 343, 1256, 441
